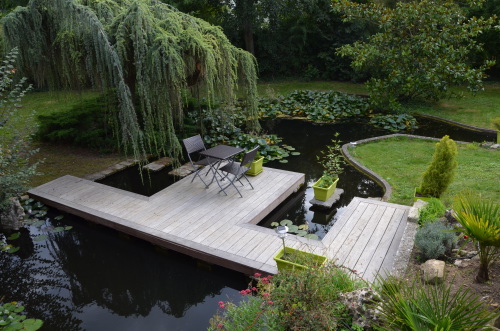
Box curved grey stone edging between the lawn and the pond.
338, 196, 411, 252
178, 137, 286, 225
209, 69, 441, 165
342, 133, 470, 201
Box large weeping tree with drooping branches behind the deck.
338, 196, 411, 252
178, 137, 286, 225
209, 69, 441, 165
2, 0, 259, 159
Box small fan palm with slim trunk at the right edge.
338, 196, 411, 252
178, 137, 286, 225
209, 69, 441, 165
454, 190, 500, 283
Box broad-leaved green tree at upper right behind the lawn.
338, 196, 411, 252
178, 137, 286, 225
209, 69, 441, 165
333, 0, 495, 109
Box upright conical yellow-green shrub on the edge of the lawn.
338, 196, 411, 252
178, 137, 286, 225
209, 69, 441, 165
420, 135, 458, 198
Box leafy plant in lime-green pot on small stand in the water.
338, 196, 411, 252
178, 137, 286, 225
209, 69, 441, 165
312, 133, 345, 201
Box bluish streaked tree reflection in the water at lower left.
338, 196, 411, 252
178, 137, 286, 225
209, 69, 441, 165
0, 229, 81, 330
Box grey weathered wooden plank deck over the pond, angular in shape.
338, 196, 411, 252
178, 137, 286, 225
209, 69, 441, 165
29, 168, 409, 281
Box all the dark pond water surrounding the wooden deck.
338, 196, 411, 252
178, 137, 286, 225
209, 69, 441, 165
0, 115, 494, 331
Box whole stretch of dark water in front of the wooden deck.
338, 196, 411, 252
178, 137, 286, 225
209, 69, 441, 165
0, 216, 247, 330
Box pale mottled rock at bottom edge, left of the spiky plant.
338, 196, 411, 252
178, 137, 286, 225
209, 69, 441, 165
340, 287, 380, 330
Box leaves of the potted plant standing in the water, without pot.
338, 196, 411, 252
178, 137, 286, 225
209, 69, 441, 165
316, 132, 345, 188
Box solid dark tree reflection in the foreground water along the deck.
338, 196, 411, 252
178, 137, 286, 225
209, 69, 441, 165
48, 218, 244, 317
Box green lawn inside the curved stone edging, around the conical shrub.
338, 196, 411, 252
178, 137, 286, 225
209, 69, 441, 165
350, 137, 500, 206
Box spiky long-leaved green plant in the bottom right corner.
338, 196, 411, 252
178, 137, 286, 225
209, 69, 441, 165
379, 277, 498, 330
